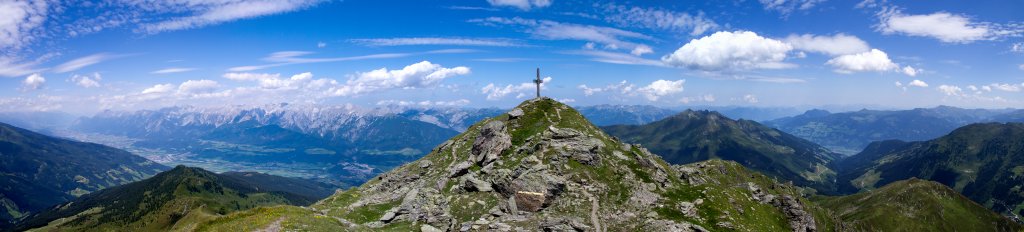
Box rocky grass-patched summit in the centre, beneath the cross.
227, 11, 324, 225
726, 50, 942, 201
197, 98, 836, 231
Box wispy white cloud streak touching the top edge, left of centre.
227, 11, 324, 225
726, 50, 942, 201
138, 0, 319, 34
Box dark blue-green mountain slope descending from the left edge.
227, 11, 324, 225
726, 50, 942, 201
0, 123, 168, 225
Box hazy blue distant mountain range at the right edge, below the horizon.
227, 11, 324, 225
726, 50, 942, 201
765, 106, 1024, 154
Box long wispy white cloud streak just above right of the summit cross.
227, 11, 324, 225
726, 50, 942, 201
469, 17, 653, 53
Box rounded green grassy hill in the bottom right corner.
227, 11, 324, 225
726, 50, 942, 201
817, 178, 1024, 231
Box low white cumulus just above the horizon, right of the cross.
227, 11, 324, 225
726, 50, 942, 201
578, 80, 686, 101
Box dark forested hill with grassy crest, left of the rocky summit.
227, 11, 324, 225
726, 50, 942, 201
18, 166, 333, 231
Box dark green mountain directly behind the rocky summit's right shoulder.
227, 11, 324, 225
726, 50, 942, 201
602, 110, 839, 192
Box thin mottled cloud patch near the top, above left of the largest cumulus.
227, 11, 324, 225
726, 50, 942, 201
597, 3, 719, 36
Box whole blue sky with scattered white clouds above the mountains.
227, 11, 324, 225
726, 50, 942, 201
0, 0, 1024, 113
